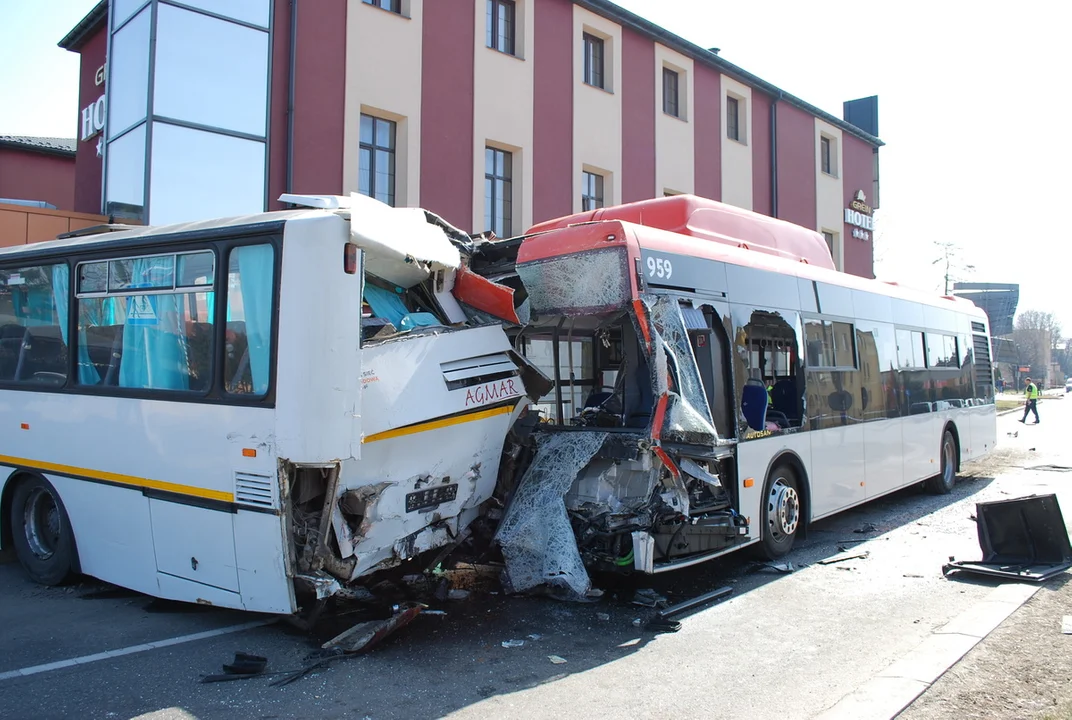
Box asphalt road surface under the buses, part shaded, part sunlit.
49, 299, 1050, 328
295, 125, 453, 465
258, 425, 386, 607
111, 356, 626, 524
0, 400, 1072, 719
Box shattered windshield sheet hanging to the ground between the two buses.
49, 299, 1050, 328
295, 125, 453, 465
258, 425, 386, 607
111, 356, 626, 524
495, 433, 607, 598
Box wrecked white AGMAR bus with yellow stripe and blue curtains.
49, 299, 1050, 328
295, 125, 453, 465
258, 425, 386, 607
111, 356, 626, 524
0, 196, 545, 614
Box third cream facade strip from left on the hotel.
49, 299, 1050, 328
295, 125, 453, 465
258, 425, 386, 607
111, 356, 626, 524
572, 5, 622, 212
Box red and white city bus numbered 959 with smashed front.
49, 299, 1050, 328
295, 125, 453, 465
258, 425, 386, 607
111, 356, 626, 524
490, 196, 996, 593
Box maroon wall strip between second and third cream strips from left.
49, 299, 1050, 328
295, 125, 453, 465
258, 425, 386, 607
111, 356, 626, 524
533, 0, 574, 223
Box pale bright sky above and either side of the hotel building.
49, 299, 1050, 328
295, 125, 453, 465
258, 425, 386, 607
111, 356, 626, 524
0, 0, 1072, 335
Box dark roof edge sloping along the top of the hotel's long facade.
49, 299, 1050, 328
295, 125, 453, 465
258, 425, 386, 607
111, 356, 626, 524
574, 0, 885, 148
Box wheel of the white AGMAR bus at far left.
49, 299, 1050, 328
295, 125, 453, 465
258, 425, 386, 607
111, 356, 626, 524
11, 476, 76, 585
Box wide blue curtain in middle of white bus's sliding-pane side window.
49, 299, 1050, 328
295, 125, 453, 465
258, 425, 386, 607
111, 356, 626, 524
119, 258, 190, 390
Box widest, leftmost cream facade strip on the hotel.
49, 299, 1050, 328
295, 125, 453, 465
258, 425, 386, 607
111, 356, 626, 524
342, 0, 424, 207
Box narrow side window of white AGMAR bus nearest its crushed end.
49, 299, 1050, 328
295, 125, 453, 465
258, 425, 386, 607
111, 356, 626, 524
223, 243, 276, 395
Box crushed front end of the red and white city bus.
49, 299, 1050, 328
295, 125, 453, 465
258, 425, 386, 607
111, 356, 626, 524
482, 222, 748, 597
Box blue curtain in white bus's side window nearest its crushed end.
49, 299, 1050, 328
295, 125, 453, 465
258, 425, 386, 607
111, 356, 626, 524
227, 245, 276, 395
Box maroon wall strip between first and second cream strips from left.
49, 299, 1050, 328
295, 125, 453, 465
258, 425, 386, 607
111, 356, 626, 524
420, 0, 475, 227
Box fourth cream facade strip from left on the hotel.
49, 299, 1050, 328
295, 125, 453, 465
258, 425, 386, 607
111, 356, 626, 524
654, 43, 696, 195
